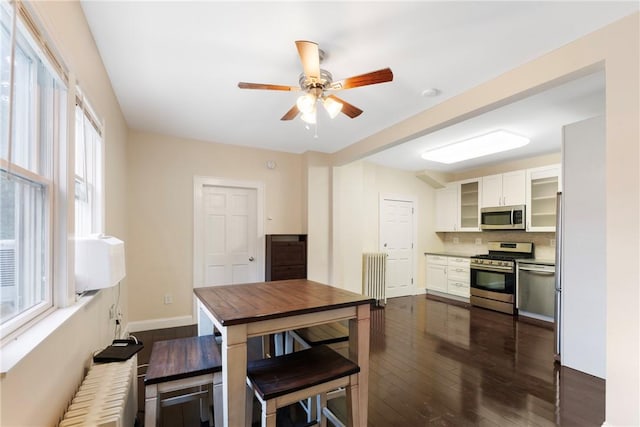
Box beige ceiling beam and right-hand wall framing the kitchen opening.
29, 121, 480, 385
334, 13, 640, 426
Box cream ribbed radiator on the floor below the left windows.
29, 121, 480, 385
59, 356, 138, 427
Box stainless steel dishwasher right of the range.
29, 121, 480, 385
517, 260, 556, 322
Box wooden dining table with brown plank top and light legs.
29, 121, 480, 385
194, 279, 374, 427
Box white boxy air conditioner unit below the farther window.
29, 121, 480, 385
75, 236, 125, 293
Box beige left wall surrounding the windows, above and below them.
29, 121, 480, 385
0, 2, 129, 427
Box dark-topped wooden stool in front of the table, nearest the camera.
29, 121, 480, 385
247, 345, 360, 427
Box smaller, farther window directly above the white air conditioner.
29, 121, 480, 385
75, 100, 103, 237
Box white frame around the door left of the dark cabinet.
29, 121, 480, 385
192, 176, 265, 288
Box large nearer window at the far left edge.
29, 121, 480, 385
0, 2, 67, 336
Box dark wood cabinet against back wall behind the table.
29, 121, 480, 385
265, 234, 307, 281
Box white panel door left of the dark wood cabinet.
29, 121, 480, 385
202, 186, 258, 285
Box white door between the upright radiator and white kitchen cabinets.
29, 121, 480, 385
380, 197, 415, 298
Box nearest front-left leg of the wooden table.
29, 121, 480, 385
222, 325, 247, 427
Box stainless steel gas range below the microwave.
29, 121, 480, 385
471, 242, 533, 314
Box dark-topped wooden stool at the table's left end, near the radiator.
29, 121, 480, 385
144, 335, 222, 427
